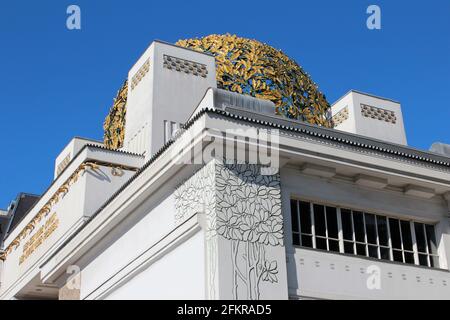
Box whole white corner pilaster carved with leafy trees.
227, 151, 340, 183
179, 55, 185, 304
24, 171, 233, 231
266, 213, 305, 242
176, 160, 288, 300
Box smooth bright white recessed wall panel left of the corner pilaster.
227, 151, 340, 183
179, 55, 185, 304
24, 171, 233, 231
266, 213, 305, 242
106, 231, 205, 300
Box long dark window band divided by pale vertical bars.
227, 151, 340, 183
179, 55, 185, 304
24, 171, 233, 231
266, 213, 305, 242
291, 199, 439, 268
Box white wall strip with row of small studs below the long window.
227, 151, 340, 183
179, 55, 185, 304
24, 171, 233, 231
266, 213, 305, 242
288, 248, 450, 299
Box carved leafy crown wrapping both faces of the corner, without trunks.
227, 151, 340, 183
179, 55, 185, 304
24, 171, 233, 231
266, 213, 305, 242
175, 161, 283, 246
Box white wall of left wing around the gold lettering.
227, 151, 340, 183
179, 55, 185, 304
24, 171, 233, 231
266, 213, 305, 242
0, 152, 139, 298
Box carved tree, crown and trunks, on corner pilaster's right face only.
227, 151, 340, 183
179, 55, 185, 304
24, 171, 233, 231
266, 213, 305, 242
216, 164, 283, 299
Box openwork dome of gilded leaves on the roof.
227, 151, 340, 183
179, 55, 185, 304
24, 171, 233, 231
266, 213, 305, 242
104, 34, 332, 148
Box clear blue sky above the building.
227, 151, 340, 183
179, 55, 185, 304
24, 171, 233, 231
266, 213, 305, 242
0, 0, 450, 208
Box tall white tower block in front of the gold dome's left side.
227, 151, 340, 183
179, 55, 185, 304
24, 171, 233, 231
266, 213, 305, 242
124, 41, 216, 159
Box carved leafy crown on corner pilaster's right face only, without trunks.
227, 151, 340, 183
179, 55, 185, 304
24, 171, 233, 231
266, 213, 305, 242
216, 164, 283, 246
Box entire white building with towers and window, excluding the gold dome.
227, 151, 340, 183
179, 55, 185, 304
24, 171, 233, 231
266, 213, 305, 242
0, 41, 450, 300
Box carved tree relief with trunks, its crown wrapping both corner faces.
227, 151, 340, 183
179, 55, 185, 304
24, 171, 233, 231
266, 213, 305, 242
176, 161, 283, 299
